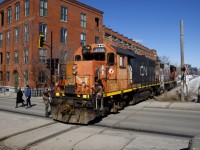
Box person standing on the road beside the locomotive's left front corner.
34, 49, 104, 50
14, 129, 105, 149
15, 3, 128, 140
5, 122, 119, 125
43, 84, 51, 117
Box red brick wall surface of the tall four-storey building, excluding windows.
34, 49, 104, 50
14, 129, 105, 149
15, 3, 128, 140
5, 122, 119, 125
0, 0, 103, 87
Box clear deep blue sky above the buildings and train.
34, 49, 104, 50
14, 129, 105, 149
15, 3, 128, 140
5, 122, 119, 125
78, 0, 200, 68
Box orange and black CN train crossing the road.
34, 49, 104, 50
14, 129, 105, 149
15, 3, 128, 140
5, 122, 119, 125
51, 44, 176, 124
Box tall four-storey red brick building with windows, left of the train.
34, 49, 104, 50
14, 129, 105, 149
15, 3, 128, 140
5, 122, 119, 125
0, 0, 103, 90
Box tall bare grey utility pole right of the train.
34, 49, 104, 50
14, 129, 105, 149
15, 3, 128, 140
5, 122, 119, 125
180, 20, 185, 102
